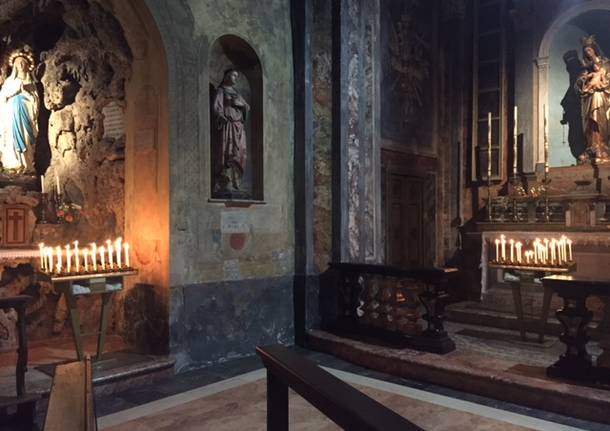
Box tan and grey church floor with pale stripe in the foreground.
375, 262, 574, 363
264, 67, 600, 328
96, 348, 610, 431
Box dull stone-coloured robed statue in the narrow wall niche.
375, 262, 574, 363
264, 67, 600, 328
213, 68, 250, 192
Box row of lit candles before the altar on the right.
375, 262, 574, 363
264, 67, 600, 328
494, 235, 573, 266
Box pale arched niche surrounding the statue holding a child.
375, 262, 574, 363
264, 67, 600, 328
533, 0, 610, 166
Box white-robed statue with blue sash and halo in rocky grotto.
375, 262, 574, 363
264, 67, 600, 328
0, 46, 39, 174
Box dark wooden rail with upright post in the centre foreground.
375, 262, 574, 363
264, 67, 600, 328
256, 345, 422, 431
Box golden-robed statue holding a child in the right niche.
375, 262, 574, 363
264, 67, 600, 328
574, 36, 610, 163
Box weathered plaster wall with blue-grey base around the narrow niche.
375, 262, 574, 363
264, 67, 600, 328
146, 0, 294, 370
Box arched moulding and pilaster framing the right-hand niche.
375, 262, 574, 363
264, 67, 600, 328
532, 0, 610, 169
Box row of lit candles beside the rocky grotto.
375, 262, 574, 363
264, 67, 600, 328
38, 238, 131, 274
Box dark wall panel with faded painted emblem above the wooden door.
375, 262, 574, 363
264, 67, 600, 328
380, 0, 436, 149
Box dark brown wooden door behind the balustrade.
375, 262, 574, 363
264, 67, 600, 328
387, 174, 422, 268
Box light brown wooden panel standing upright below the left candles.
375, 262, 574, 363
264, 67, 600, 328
44, 355, 97, 431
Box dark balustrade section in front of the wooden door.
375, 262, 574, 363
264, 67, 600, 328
320, 262, 457, 353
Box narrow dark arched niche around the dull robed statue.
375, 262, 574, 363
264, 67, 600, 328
208, 34, 264, 201
